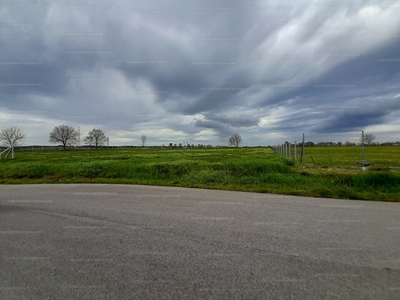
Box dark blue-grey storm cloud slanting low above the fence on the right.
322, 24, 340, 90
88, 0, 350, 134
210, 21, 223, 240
262, 38, 400, 133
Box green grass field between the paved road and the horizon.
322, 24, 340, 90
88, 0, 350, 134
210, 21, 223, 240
0, 147, 400, 201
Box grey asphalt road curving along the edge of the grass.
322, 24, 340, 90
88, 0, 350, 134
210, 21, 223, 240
0, 184, 400, 300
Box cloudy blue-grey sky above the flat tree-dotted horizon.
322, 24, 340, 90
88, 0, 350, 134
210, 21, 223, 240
0, 0, 400, 146
